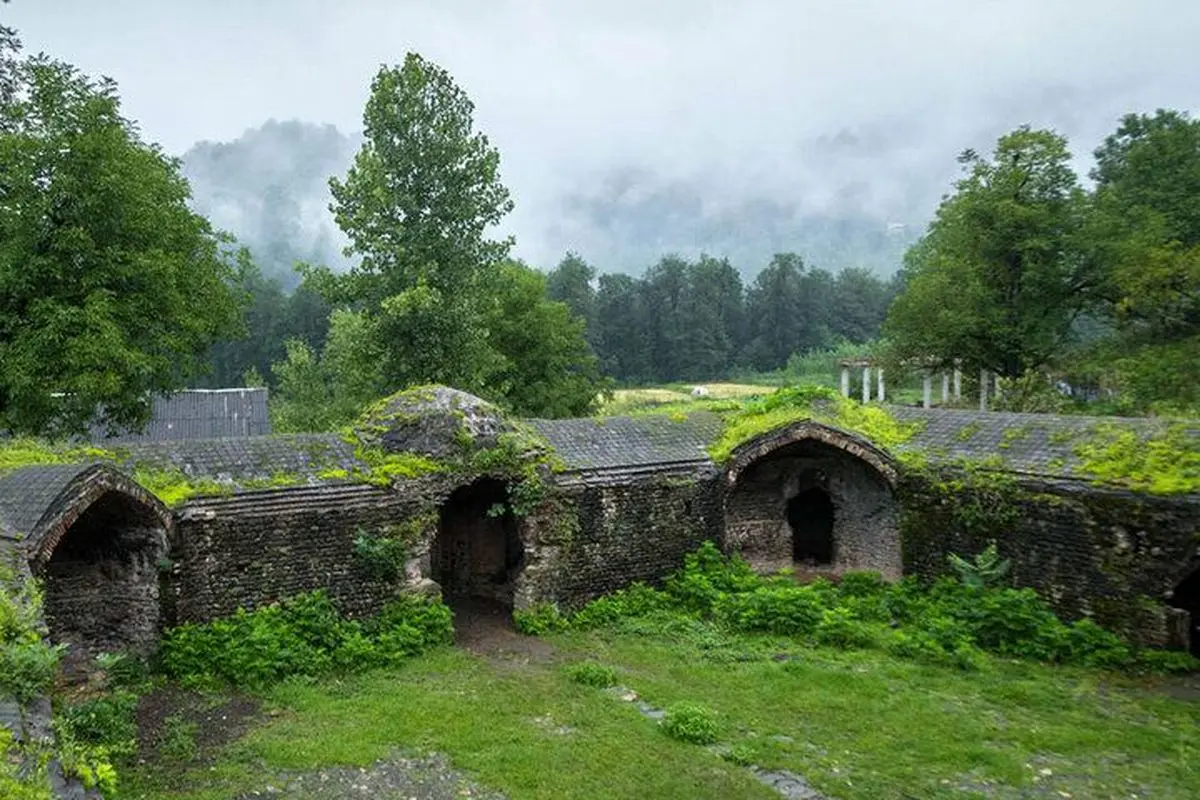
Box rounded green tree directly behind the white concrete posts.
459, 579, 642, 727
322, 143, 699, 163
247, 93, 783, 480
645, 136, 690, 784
884, 127, 1099, 378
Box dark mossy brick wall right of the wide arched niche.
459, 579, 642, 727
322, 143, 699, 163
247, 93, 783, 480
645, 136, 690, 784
900, 475, 1200, 644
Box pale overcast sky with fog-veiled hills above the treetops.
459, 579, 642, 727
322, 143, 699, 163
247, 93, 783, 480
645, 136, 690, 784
4, 0, 1200, 283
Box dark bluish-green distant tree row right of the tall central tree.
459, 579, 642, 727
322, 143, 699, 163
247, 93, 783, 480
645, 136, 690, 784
547, 253, 900, 384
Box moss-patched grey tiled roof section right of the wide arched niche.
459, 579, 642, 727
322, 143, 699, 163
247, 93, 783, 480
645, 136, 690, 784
890, 407, 1200, 477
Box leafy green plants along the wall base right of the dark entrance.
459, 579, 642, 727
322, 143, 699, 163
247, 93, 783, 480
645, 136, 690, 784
517, 542, 1200, 672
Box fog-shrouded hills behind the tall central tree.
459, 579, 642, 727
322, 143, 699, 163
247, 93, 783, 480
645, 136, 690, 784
182, 120, 924, 287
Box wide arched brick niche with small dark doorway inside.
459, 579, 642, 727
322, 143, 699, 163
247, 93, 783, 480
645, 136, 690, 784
725, 421, 902, 578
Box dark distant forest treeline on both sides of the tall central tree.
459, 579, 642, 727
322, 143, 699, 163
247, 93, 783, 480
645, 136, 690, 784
198, 253, 900, 387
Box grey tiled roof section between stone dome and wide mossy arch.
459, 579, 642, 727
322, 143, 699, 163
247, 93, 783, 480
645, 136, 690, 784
529, 411, 721, 470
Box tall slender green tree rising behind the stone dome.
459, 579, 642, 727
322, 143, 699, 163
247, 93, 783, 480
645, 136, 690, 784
325, 53, 512, 391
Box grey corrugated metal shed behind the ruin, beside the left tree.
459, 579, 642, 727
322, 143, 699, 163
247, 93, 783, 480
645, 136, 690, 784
89, 389, 271, 445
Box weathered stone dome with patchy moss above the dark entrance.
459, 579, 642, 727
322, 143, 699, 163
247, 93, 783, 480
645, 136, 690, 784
354, 386, 510, 461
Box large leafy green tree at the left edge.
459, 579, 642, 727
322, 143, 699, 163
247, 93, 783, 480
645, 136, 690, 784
0, 50, 238, 433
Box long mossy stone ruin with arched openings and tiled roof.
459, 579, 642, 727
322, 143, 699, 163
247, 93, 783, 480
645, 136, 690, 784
0, 387, 1200, 681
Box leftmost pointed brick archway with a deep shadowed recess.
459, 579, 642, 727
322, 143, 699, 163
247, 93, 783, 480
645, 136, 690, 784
30, 465, 173, 674
